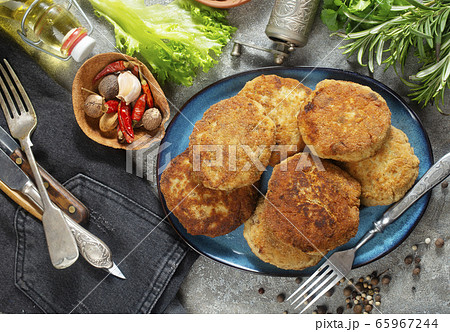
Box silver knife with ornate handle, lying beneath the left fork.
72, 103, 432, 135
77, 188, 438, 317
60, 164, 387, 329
0, 148, 126, 279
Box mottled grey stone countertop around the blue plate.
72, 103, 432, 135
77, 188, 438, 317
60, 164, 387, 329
5, 0, 450, 314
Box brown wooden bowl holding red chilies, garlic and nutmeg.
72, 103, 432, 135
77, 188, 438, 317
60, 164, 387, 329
72, 53, 170, 150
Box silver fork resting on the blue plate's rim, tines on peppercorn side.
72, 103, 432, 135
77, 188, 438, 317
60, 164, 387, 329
287, 153, 450, 313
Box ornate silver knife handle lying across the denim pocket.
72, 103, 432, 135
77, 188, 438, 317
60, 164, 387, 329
26, 185, 113, 269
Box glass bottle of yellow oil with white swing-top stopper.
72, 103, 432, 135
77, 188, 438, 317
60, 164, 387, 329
0, 0, 95, 61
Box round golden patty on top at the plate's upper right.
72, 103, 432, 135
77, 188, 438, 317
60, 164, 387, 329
298, 80, 391, 161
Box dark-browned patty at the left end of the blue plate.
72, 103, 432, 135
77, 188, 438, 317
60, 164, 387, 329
160, 150, 257, 237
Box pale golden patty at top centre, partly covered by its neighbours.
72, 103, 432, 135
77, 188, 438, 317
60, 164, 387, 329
238, 75, 311, 166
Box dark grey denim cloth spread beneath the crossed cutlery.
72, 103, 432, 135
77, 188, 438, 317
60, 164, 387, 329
0, 31, 197, 313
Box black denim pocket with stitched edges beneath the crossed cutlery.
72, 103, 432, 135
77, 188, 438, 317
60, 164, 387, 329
16, 175, 193, 313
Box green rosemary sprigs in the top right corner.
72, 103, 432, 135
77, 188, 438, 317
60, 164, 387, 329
341, 0, 450, 114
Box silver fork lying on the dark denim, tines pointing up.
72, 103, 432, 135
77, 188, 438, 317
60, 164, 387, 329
0, 60, 78, 269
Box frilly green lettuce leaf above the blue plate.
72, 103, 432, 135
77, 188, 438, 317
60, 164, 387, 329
89, 0, 236, 86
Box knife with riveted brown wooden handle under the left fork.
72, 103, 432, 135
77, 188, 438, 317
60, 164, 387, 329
0, 126, 89, 224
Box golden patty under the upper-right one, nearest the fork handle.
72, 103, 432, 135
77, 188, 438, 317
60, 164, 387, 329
342, 126, 419, 206
